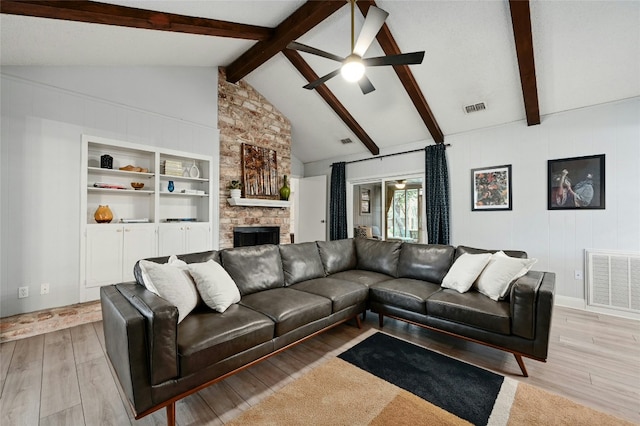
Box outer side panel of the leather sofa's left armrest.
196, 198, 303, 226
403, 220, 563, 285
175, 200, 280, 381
100, 285, 153, 413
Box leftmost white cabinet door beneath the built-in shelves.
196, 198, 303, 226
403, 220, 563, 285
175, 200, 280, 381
85, 225, 123, 287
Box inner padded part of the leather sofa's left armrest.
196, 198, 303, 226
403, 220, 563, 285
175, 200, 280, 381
116, 283, 179, 385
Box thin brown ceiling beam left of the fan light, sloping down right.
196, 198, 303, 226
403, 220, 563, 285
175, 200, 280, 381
282, 49, 380, 155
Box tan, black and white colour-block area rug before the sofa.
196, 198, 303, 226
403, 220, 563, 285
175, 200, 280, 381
231, 332, 632, 426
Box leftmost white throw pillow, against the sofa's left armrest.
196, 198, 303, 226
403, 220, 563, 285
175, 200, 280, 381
140, 260, 198, 324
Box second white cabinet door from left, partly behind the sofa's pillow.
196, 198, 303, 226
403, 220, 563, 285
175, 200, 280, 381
122, 224, 158, 282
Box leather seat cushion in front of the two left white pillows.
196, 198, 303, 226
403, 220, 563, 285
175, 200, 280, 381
178, 304, 275, 377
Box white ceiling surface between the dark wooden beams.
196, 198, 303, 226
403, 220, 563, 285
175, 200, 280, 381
0, 0, 640, 163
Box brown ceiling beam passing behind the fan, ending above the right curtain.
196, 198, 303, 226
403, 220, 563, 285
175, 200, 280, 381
356, 0, 444, 143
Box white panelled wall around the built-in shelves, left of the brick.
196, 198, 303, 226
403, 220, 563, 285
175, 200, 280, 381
0, 67, 219, 317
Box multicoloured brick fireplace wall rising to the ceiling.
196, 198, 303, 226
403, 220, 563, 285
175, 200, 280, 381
218, 68, 291, 248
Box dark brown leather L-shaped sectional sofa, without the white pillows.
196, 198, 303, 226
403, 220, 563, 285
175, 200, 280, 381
100, 239, 555, 424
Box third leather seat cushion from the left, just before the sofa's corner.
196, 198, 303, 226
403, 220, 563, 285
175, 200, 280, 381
291, 277, 369, 312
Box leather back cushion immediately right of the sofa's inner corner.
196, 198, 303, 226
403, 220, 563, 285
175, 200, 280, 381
355, 238, 402, 277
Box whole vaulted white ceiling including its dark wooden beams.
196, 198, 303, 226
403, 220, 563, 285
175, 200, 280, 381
0, 0, 640, 162
